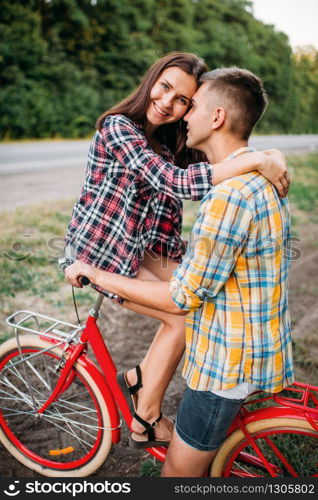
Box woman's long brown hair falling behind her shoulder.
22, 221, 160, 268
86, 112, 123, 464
96, 52, 207, 168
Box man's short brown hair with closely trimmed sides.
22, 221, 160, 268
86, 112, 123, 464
200, 67, 268, 140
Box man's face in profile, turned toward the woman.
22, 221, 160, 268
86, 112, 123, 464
184, 83, 214, 151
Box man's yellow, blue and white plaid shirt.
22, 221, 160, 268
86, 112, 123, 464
170, 172, 294, 392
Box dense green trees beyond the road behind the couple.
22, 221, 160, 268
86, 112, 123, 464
0, 0, 318, 139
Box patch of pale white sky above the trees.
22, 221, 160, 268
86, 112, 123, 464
252, 0, 318, 50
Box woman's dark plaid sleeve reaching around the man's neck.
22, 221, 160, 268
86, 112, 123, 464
101, 115, 213, 200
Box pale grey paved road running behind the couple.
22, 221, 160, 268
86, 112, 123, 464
0, 135, 318, 210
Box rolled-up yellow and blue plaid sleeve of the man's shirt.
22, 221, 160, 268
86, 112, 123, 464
170, 184, 252, 311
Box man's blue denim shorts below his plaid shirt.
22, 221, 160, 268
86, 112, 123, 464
176, 387, 244, 451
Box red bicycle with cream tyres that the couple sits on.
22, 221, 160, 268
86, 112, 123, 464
0, 295, 318, 477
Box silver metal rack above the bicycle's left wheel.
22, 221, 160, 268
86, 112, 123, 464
6, 310, 85, 344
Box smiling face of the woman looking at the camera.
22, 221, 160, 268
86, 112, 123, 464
146, 66, 198, 130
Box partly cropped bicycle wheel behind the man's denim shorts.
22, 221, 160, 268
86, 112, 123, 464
210, 417, 318, 477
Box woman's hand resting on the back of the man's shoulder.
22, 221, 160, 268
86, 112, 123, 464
259, 149, 290, 198
